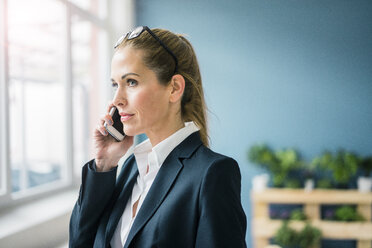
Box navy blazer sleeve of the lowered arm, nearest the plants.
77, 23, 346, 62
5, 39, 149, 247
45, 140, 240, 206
195, 157, 247, 248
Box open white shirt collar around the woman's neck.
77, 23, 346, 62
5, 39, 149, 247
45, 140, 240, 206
134, 121, 199, 175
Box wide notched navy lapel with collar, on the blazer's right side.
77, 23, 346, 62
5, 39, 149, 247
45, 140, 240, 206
124, 132, 202, 248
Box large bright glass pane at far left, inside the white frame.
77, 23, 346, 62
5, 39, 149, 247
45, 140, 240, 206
8, 0, 66, 192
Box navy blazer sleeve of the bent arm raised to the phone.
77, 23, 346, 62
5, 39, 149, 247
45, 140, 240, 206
69, 160, 117, 247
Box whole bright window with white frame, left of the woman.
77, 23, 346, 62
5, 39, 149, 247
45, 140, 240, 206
0, 0, 109, 205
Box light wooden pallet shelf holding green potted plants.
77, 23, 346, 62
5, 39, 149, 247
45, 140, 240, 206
251, 189, 372, 248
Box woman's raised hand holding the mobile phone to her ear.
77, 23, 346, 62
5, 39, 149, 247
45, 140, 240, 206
93, 103, 133, 172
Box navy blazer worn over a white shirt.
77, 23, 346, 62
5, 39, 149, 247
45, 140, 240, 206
69, 132, 247, 248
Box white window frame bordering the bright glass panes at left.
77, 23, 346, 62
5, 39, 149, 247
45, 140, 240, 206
0, 0, 110, 210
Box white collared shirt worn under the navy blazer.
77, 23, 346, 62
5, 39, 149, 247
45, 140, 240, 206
110, 122, 199, 248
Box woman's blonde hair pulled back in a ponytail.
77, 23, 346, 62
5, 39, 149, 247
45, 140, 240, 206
117, 29, 209, 146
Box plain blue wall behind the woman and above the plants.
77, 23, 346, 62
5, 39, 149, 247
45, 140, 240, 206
137, 0, 372, 246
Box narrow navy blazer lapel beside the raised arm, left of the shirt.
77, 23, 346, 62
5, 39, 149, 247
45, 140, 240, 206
105, 156, 138, 244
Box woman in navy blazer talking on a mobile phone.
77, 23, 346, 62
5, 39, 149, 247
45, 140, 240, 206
70, 27, 246, 248
